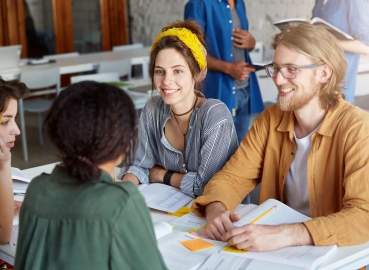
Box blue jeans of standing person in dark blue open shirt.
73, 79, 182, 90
234, 86, 250, 143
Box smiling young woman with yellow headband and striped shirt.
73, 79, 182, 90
118, 21, 238, 198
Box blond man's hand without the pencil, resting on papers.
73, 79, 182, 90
205, 202, 241, 240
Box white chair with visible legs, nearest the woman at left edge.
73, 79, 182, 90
18, 67, 60, 161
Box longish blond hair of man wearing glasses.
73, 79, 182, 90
271, 24, 347, 110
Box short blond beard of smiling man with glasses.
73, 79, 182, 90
277, 75, 321, 111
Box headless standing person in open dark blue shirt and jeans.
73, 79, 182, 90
184, 0, 264, 142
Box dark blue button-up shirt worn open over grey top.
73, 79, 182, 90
185, 0, 264, 117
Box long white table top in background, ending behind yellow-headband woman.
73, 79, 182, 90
0, 47, 151, 80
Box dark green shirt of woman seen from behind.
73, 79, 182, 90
15, 166, 166, 270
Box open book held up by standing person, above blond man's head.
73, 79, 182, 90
273, 17, 354, 40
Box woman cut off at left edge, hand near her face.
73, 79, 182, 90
0, 78, 28, 244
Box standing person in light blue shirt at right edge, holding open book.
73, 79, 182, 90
313, 0, 369, 103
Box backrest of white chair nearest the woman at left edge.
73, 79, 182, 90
19, 66, 60, 96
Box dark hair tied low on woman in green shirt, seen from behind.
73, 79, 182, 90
43, 81, 137, 183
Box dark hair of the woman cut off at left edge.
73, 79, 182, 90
0, 77, 29, 113
